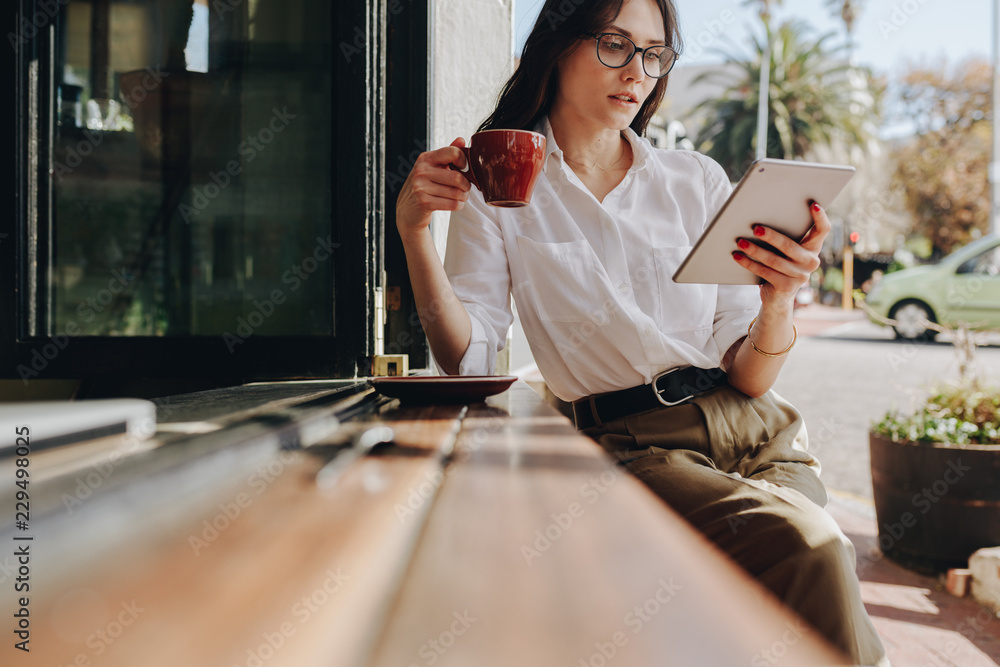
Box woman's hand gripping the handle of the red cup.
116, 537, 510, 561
396, 137, 472, 236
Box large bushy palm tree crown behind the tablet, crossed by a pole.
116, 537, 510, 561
695, 22, 876, 181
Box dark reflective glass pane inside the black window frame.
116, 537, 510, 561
51, 0, 337, 337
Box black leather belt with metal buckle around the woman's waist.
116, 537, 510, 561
573, 366, 726, 429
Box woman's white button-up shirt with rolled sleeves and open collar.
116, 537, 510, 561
438, 120, 760, 401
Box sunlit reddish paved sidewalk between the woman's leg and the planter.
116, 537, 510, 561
827, 492, 1000, 667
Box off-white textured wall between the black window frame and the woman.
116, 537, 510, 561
431, 0, 515, 373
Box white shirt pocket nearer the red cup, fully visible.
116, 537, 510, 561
517, 236, 601, 322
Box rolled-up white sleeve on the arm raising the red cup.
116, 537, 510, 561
434, 189, 514, 375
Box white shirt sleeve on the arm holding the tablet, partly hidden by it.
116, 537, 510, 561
702, 158, 760, 354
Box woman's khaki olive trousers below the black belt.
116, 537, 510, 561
580, 386, 889, 667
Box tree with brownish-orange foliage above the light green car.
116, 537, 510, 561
894, 60, 993, 256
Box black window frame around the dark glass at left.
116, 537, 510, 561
0, 0, 430, 383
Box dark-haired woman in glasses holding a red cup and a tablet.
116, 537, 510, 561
397, 0, 887, 665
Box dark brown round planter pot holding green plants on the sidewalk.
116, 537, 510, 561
869, 433, 1000, 572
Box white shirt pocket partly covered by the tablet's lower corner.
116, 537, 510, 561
653, 246, 718, 334
